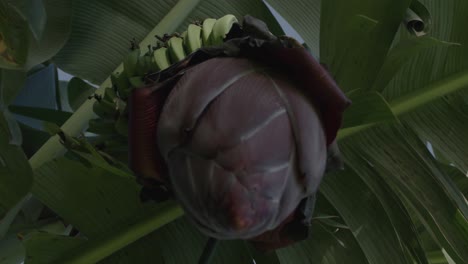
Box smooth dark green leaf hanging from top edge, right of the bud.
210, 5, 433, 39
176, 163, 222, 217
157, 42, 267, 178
320, 0, 411, 91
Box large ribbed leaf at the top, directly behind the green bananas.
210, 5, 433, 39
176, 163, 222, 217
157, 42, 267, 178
54, 0, 282, 83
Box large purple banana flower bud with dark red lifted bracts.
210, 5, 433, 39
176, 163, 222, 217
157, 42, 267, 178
129, 16, 350, 250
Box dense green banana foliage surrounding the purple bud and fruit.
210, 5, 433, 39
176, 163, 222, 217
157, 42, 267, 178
0, 0, 468, 264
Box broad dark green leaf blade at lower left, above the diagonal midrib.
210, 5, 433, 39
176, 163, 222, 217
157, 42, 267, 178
32, 158, 143, 239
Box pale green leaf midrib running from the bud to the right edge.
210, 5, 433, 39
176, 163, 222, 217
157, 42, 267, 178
338, 71, 468, 140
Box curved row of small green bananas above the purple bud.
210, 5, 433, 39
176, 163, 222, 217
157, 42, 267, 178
88, 15, 238, 155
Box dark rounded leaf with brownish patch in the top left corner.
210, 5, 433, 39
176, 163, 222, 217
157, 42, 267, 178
0, 0, 72, 70
